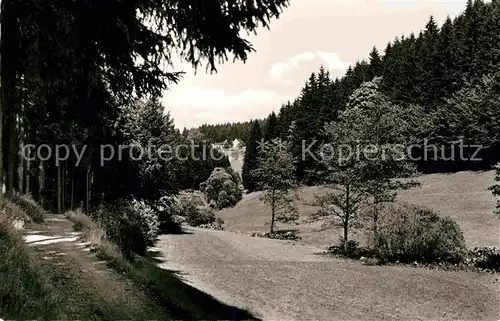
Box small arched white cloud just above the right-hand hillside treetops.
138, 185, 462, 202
268, 51, 350, 79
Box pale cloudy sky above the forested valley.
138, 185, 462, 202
162, 0, 466, 128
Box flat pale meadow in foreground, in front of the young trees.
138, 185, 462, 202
157, 228, 500, 320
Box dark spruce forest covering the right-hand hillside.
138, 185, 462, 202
243, 0, 500, 188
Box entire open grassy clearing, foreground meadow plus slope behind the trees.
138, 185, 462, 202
152, 172, 500, 320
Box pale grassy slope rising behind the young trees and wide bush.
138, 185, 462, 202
217, 171, 500, 247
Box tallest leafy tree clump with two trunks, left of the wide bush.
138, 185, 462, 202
316, 78, 416, 250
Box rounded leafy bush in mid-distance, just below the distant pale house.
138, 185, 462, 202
200, 167, 242, 209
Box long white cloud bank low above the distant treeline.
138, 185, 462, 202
163, 86, 290, 128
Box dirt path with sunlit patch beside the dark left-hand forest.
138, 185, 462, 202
24, 215, 161, 319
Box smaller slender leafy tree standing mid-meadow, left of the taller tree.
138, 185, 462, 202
252, 138, 299, 234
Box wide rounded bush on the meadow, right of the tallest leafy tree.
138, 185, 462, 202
374, 204, 465, 263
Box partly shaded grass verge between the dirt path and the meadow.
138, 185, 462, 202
67, 211, 258, 320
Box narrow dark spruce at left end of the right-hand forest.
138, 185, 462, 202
241, 120, 262, 192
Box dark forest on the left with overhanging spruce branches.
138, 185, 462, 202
0, 0, 288, 213
